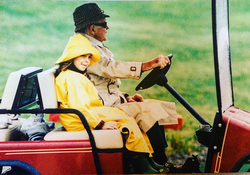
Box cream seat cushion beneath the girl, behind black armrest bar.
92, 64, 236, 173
44, 128, 123, 149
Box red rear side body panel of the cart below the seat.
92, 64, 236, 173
0, 141, 123, 174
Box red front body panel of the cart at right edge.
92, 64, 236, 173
212, 106, 250, 173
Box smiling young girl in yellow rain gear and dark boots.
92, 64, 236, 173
55, 34, 172, 173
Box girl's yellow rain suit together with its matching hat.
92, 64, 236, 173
56, 35, 153, 153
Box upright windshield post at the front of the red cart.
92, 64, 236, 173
205, 0, 234, 173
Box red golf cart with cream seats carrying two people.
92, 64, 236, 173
0, 0, 250, 175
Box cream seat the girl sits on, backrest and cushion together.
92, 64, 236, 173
37, 67, 123, 149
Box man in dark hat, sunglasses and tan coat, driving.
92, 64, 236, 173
73, 3, 177, 165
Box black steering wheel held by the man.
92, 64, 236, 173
135, 54, 173, 91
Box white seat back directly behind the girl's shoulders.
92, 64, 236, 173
36, 67, 58, 109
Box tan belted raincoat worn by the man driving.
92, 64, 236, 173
79, 34, 178, 132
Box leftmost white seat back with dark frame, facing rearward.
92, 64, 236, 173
0, 67, 43, 109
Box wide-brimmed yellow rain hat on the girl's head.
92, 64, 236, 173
55, 34, 101, 66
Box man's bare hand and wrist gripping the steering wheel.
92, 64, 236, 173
142, 55, 170, 71
